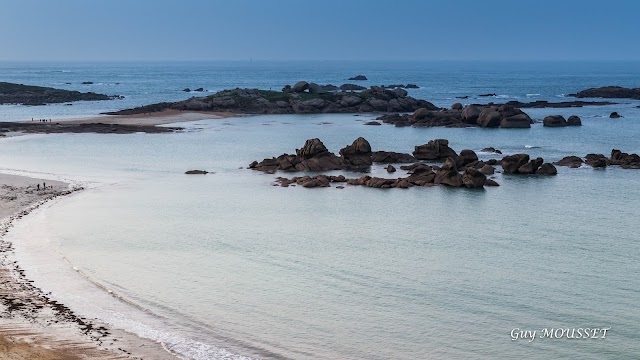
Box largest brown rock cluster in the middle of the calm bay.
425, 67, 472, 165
249, 137, 557, 188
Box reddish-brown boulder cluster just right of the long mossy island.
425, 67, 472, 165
377, 103, 533, 128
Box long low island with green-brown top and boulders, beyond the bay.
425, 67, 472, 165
106, 87, 437, 115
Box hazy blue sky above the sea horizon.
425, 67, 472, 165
0, 0, 640, 61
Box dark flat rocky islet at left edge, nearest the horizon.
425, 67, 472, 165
0, 82, 122, 105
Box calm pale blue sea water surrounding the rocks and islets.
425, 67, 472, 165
0, 62, 640, 359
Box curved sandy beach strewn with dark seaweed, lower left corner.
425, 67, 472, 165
0, 174, 176, 360
